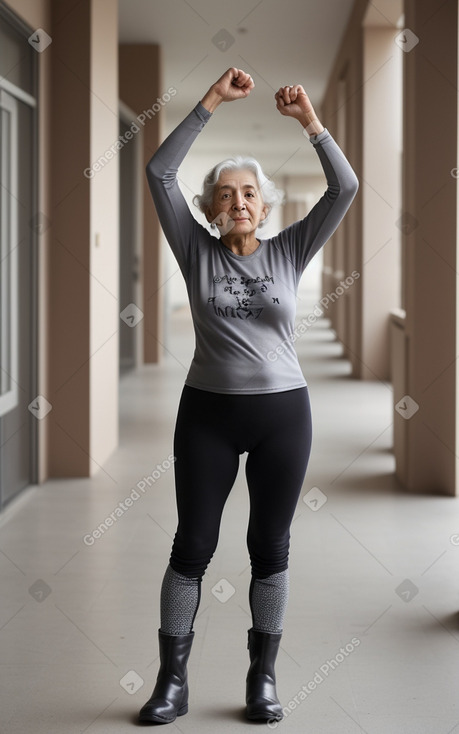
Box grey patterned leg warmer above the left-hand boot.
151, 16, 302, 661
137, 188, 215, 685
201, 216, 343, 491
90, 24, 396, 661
160, 564, 201, 635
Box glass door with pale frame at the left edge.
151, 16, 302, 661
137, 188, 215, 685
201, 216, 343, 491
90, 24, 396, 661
0, 88, 36, 509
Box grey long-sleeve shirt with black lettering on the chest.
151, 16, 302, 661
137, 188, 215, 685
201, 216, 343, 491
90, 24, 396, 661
146, 102, 359, 394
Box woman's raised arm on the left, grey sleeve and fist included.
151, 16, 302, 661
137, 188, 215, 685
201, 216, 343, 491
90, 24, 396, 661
146, 68, 254, 275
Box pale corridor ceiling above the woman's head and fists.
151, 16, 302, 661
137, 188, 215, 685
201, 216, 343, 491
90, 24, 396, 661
118, 0, 354, 176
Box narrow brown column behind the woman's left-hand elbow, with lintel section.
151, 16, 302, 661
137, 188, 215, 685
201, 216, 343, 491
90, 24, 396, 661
119, 43, 164, 363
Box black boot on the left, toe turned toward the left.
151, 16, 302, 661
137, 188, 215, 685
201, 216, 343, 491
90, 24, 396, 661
139, 629, 194, 724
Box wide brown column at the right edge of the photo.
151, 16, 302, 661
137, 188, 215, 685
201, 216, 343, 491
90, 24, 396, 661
400, 0, 458, 495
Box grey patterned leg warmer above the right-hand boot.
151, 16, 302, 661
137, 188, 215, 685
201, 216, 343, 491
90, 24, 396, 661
249, 568, 289, 632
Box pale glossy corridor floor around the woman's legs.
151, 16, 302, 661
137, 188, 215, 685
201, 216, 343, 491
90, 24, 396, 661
0, 278, 459, 734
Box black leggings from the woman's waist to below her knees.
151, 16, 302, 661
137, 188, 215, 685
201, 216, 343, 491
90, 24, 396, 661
169, 385, 312, 579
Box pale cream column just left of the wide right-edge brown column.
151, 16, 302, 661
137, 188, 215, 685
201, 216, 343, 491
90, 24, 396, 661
361, 21, 403, 380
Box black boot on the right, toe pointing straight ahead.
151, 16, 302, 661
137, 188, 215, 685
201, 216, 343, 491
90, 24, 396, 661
246, 627, 283, 721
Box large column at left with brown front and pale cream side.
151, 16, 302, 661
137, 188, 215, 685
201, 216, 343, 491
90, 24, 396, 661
46, 0, 119, 477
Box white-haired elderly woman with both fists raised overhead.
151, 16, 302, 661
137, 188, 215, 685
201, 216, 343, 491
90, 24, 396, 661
139, 68, 358, 723
